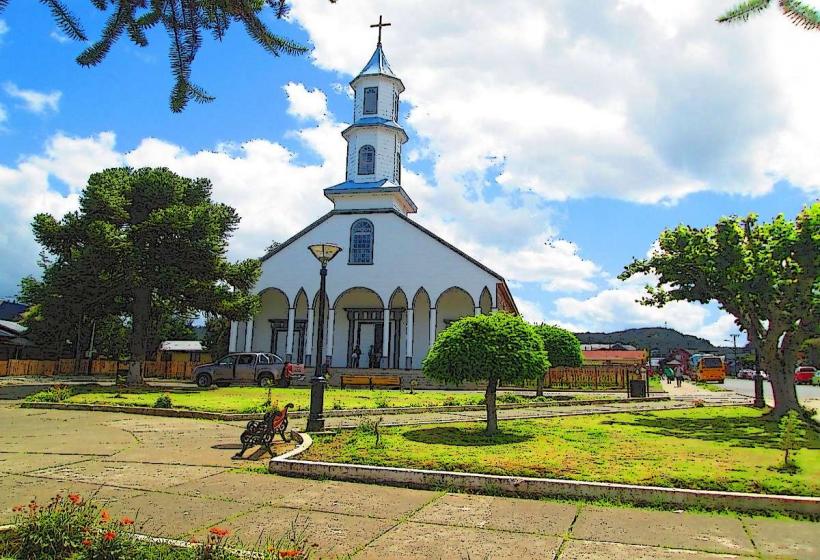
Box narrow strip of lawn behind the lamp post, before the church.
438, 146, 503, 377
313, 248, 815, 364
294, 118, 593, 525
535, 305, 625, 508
44, 386, 623, 413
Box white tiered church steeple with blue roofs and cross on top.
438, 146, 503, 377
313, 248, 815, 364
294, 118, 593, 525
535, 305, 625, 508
325, 16, 416, 213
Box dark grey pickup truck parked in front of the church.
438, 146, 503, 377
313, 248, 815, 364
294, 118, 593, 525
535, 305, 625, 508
194, 352, 288, 387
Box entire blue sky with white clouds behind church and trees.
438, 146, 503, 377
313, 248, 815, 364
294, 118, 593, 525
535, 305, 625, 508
0, 0, 820, 345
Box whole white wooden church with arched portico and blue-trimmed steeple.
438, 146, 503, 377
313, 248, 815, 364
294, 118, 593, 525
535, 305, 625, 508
230, 27, 518, 379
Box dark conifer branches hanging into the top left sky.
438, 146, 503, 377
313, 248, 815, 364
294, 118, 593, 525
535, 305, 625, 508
0, 0, 308, 113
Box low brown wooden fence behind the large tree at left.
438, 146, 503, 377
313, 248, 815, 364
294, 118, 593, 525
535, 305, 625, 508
0, 359, 199, 379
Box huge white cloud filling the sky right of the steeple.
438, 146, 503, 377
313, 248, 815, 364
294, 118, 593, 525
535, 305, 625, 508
292, 0, 820, 203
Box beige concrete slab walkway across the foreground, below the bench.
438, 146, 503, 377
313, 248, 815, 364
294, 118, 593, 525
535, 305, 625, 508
0, 403, 820, 560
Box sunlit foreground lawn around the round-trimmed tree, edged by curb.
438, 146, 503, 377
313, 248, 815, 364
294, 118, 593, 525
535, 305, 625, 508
304, 407, 820, 496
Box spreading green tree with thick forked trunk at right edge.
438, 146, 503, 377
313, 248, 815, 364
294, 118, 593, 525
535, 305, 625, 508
620, 202, 820, 418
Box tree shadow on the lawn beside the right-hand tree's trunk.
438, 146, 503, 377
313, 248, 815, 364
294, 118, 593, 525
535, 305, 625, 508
602, 414, 820, 449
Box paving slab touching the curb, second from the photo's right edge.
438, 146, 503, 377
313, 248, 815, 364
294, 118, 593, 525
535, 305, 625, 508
572, 507, 755, 554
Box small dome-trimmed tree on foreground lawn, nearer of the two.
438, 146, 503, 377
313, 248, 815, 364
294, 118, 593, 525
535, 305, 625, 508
422, 312, 549, 435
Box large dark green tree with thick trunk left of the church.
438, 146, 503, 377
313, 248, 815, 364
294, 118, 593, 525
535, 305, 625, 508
33, 168, 260, 384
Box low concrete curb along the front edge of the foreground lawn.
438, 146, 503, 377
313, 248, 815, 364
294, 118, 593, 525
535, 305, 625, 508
268, 456, 820, 519
